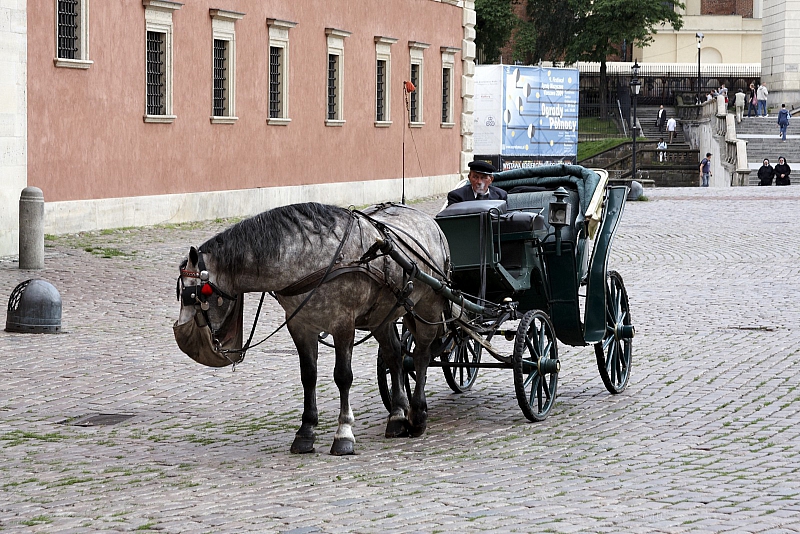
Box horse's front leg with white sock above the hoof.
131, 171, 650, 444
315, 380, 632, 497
331, 328, 356, 456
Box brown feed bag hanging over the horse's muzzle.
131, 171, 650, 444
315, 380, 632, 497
172, 295, 244, 367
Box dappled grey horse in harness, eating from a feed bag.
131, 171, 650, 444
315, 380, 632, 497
174, 203, 449, 455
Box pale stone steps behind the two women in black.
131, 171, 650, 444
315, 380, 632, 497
736, 113, 800, 185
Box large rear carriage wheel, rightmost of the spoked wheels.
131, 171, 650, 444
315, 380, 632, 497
594, 271, 634, 394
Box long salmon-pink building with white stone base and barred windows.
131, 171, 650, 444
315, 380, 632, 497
0, 0, 475, 255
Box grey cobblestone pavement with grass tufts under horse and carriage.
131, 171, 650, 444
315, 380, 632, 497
0, 187, 800, 534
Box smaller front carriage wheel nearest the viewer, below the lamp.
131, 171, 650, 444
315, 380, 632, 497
511, 310, 561, 421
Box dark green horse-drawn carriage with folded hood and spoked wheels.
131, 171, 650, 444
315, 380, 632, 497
377, 165, 634, 421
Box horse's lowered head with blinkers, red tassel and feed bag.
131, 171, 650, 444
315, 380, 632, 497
172, 247, 244, 367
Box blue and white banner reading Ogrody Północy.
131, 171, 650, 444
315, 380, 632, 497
501, 65, 579, 161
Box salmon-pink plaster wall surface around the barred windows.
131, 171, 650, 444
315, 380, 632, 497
28, 0, 464, 202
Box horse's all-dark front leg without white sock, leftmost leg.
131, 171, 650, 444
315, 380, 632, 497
288, 325, 319, 454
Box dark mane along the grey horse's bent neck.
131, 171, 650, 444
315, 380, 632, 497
200, 202, 349, 272
